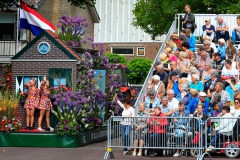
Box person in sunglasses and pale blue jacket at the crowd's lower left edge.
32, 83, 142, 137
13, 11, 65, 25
145, 89, 160, 112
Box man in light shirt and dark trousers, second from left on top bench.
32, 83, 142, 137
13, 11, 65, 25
215, 16, 229, 41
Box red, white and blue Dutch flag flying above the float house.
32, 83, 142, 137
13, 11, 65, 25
20, 3, 55, 36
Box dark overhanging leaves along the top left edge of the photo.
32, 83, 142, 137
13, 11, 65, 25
0, 0, 96, 10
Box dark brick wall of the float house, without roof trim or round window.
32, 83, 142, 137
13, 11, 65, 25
11, 37, 77, 128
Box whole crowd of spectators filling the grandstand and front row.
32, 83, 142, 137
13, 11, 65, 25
115, 5, 240, 157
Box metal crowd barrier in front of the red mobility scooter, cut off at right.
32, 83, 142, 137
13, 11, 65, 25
203, 117, 240, 158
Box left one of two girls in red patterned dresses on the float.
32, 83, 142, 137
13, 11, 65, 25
24, 78, 40, 130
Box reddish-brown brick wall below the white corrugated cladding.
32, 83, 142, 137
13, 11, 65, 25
104, 42, 162, 61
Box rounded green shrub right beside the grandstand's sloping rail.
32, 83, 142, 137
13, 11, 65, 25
127, 58, 153, 84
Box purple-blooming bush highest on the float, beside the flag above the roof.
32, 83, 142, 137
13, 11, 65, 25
57, 14, 89, 47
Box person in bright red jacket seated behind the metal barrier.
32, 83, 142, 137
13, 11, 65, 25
147, 106, 168, 157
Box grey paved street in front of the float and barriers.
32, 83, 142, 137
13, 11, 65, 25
0, 141, 232, 160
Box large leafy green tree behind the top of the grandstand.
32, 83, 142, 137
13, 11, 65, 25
132, 0, 240, 40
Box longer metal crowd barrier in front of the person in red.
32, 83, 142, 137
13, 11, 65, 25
104, 116, 206, 160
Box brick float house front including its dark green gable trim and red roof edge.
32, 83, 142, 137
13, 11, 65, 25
11, 31, 81, 127
